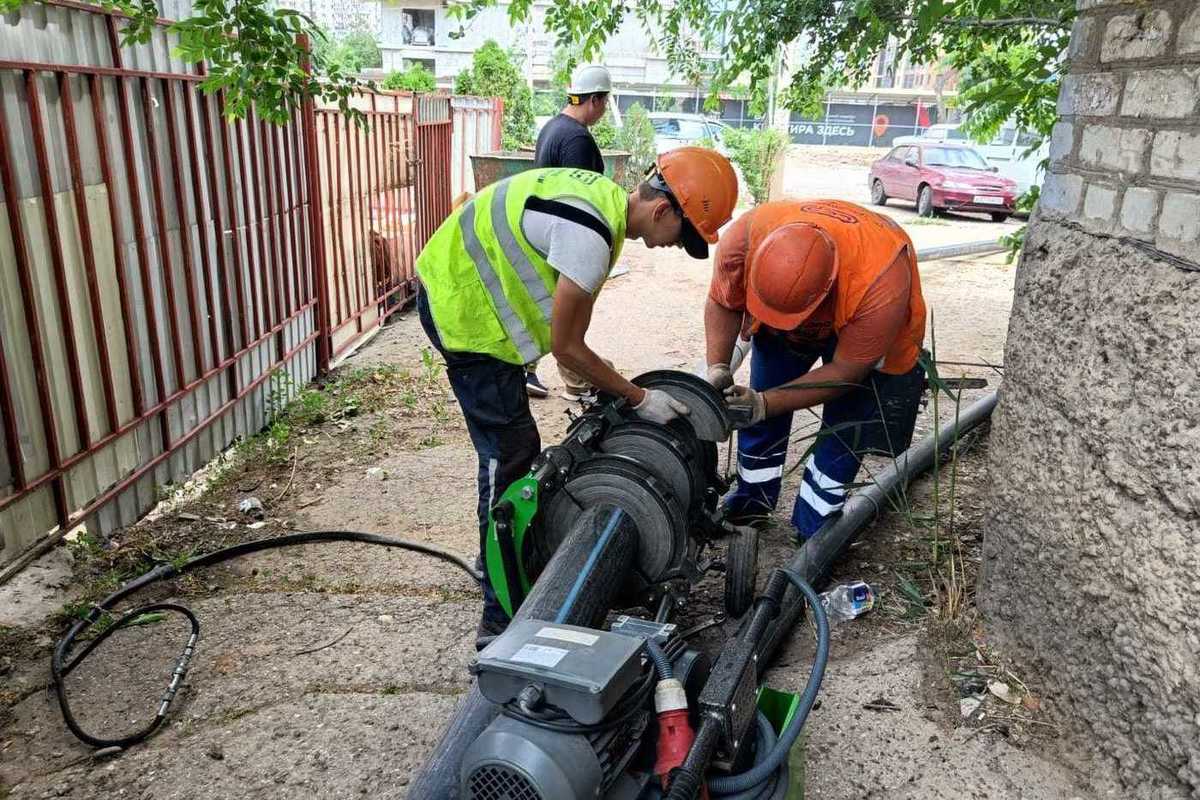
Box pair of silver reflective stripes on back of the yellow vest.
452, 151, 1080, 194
458, 181, 553, 363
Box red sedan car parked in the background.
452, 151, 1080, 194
870, 142, 1016, 222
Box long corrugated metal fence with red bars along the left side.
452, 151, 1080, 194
0, 0, 498, 579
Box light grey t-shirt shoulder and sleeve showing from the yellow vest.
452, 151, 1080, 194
521, 197, 612, 295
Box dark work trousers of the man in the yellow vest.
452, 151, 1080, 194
416, 289, 541, 622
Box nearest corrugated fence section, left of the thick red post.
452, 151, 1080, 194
0, 4, 316, 563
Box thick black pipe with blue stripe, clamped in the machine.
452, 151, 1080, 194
408, 505, 637, 800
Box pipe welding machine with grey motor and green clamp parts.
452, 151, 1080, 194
446, 371, 820, 800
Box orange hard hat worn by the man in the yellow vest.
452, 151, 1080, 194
648, 148, 738, 258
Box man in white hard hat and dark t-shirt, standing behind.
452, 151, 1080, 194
526, 65, 612, 401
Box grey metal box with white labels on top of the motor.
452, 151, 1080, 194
470, 620, 644, 724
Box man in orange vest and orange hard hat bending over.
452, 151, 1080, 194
704, 200, 925, 541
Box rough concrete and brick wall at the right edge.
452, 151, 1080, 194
980, 0, 1200, 800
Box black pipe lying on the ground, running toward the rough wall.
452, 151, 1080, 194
758, 392, 996, 674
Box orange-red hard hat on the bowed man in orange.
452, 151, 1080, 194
746, 222, 838, 331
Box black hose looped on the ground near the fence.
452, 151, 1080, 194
50, 530, 482, 747
